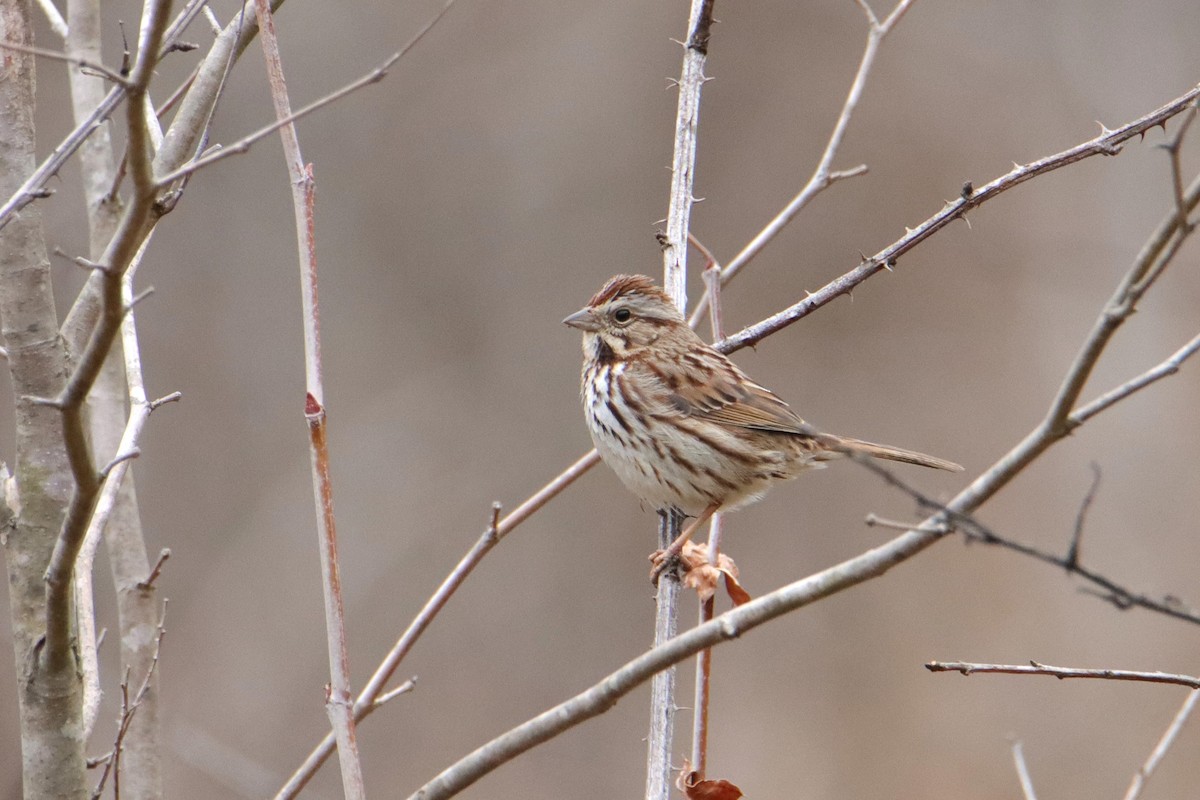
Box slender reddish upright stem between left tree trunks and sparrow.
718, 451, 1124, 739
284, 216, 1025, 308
254, 0, 366, 800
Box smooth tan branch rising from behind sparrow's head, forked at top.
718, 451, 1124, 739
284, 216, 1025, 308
691, 0, 912, 324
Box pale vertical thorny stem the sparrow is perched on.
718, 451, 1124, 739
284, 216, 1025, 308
646, 0, 713, 800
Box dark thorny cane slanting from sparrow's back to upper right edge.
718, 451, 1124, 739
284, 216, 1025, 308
715, 86, 1200, 354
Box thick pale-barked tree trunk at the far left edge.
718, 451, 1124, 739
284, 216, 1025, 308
0, 0, 86, 799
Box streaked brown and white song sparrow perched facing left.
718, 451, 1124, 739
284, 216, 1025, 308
563, 275, 962, 568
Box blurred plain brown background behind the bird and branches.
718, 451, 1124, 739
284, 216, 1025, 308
0, 0, 1200, 800
